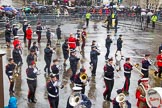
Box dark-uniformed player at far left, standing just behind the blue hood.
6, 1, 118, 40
5, 58, 16, 93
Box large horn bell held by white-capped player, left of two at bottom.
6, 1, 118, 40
69, 93, 81, 107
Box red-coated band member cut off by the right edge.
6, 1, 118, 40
156, 50, 162, 78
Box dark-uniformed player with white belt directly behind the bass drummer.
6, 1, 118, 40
141, 54, 151, 78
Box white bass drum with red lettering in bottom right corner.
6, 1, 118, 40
146, 87, 162, 108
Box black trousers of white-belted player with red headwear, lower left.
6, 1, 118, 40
27, 80, 37, 101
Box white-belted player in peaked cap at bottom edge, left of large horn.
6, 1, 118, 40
46, 73, 64, 108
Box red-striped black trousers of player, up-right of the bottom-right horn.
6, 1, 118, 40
123, 73, 131, 92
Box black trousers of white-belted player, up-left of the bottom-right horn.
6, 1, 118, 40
103, 79, 114, 100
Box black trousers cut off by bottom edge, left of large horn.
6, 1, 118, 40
48, 96, 59, 108
